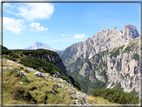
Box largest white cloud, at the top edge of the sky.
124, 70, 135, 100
16, 3, 54, 21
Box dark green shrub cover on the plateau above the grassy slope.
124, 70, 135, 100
2, 47, 81, 90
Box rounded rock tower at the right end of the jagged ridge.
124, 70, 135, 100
123, 24, 140, 39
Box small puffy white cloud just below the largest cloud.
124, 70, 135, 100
30, 22, 48, 31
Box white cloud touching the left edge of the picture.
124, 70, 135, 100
3, 17, 26, 34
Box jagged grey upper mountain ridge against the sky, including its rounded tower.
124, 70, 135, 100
60, 24, 140, 66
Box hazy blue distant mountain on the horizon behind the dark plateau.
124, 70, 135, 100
25, 42, 65, 52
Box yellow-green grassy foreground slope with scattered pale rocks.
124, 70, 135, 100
3, 58, 116, 105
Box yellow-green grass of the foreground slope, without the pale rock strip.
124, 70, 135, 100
3, 60, 114, 104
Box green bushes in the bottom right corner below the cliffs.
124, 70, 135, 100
91, 89, 139, 104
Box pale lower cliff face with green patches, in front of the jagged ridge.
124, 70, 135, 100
67, 34, 141, 94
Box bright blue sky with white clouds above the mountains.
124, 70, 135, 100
3, 3, 140, 49
